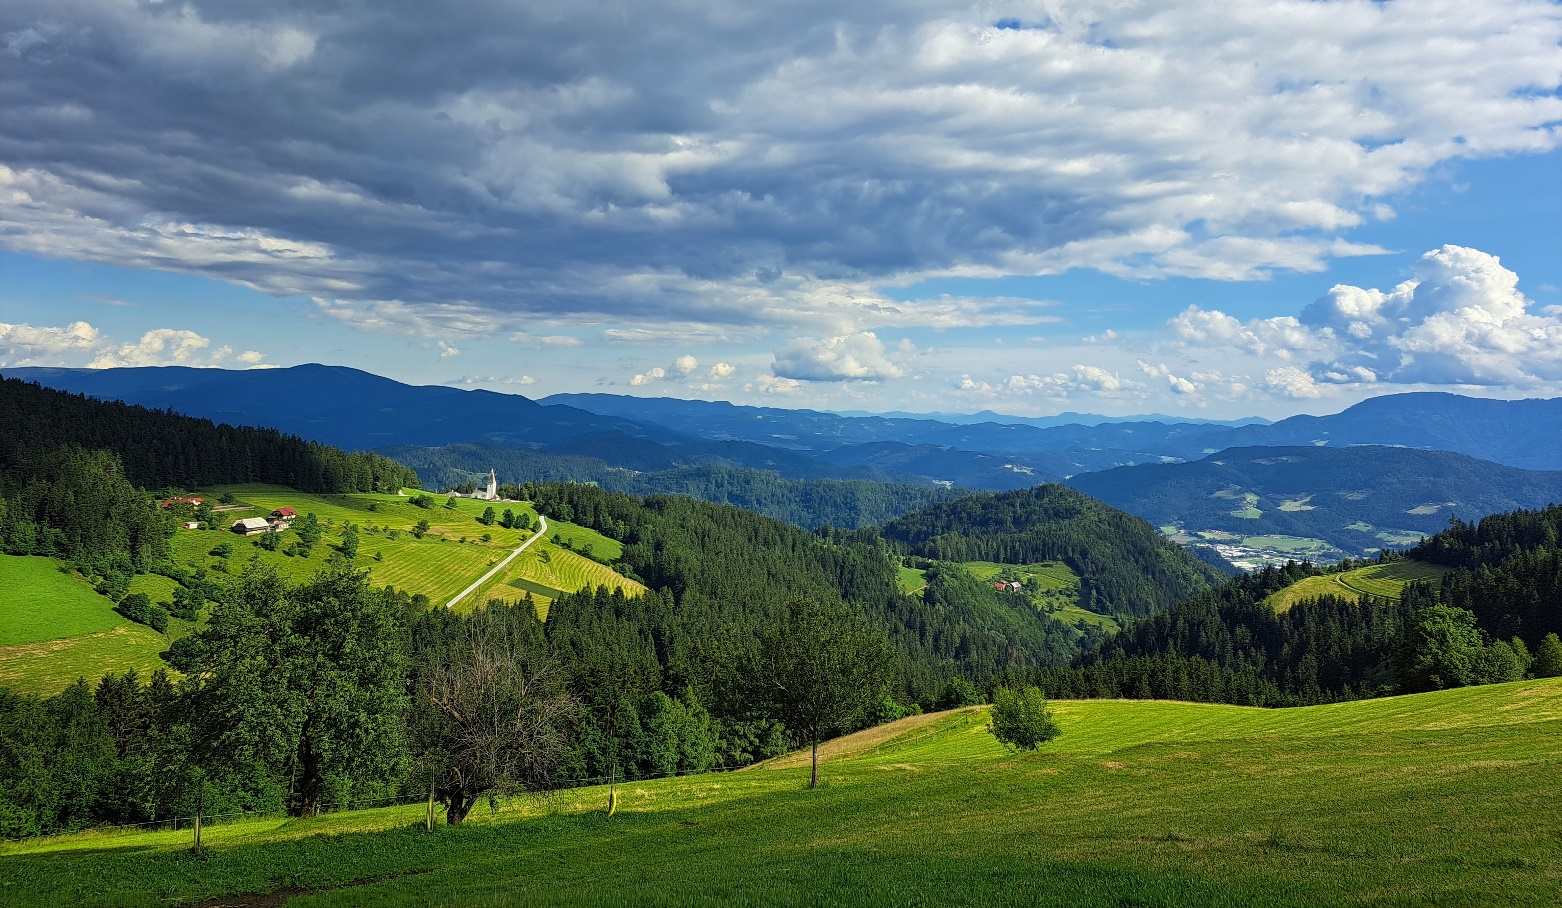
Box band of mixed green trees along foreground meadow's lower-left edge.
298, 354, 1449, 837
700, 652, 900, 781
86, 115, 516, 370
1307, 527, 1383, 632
0, 558, 887, 838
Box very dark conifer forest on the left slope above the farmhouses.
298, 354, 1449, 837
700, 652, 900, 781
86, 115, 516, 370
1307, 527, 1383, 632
0, 371, 419, 494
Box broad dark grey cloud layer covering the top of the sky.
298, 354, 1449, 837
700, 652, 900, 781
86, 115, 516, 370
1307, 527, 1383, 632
0, 0, 1562, 336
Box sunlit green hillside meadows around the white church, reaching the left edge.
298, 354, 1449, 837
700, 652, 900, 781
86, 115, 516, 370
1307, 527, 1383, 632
0, 484, 644, 695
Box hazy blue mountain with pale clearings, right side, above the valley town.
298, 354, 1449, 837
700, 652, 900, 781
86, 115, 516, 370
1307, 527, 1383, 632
1068, 445, 1562, 553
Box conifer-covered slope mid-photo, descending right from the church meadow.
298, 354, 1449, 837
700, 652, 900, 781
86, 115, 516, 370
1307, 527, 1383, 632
526, 484, 1078, 706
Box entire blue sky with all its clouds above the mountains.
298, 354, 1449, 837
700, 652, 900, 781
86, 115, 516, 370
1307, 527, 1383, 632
0, 0, 1562, 419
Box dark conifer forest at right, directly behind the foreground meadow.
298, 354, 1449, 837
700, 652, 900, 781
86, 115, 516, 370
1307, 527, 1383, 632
1042, 506, 1562, 706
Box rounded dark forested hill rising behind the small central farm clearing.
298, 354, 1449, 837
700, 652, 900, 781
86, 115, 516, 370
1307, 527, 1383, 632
883, 484, 1225, 617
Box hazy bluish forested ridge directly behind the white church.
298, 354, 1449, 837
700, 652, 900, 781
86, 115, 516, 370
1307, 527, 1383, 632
383, 444, 967, 530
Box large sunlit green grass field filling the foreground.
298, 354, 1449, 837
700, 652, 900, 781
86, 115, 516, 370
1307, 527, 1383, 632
0, 680, 1562, 908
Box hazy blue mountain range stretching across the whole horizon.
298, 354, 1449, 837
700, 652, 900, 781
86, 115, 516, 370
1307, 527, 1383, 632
5, 364, 1562, 552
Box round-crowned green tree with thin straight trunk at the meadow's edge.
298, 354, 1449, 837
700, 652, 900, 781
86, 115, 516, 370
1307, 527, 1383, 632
750, 599, 893, 788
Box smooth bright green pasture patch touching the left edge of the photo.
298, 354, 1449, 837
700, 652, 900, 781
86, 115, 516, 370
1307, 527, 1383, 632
0, 555, 123, 652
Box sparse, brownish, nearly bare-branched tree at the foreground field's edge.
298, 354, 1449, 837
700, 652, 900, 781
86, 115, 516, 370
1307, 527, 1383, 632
412, 608, 580, 825
